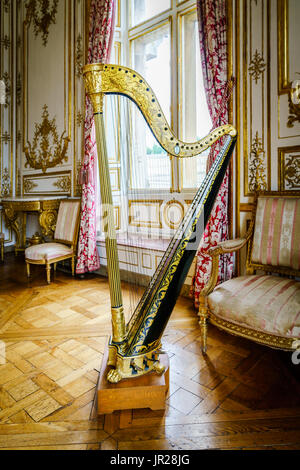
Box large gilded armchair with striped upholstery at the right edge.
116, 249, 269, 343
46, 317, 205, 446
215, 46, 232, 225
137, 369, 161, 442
199, 192, 300, 353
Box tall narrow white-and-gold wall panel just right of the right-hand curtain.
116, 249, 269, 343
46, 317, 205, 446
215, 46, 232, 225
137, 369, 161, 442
243, 0, 271, 196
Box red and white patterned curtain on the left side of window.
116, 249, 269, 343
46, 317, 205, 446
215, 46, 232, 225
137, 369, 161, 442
76, 0, 115, 273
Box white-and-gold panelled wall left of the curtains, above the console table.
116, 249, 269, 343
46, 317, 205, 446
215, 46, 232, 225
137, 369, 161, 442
0, 0, 87, 252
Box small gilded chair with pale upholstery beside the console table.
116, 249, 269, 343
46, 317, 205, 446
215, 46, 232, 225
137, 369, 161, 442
25, 199, 81, 284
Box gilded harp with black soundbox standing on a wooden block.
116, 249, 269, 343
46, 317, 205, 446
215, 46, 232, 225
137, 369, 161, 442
83, 64, 237, 383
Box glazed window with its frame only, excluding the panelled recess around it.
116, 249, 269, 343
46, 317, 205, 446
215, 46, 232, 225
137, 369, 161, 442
128, 0, 212, 192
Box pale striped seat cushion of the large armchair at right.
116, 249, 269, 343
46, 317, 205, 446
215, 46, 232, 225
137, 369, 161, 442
208, 275, 300, 338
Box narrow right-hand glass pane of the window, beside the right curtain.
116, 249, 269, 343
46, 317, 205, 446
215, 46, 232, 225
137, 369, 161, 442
181, 11, 212, 188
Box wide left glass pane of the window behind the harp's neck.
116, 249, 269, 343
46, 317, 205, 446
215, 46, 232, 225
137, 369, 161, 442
130, 24, 171, 189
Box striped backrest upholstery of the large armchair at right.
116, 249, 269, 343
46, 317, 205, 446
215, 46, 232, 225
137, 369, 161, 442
251, 197, 300, 270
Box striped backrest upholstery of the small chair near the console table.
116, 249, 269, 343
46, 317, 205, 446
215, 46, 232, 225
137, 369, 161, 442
54, 200, 80, 242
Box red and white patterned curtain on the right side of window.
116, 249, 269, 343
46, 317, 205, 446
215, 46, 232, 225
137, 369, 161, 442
192, 0, 233, 307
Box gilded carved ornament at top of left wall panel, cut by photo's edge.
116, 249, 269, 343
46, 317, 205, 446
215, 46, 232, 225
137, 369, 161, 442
25, 0, 58, 46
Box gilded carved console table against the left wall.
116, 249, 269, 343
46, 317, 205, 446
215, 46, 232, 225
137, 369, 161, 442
1, 197, 64, 254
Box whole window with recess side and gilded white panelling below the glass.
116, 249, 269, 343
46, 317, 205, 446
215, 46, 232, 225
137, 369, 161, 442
97, 0, 212, 238
